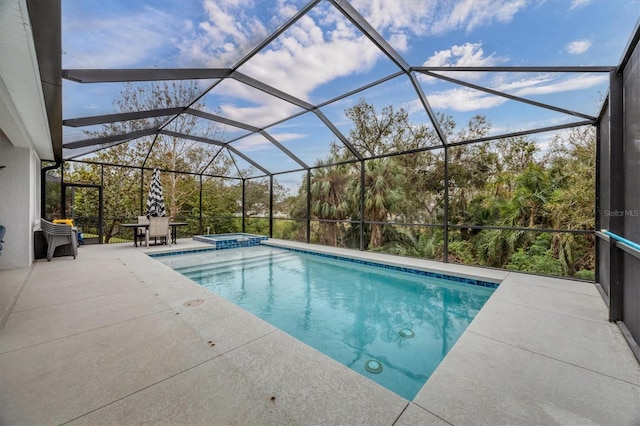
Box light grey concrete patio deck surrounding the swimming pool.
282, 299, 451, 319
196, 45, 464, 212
0, 239, 640, 425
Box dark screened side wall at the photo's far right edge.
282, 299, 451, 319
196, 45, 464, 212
597, 21, 640, 360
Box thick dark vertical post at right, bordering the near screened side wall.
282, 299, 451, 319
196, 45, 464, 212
605, 70, 625, 322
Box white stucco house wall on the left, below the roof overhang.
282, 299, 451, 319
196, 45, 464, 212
0, 132, 40, 269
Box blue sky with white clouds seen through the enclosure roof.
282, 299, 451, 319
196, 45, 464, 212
62, 0, 640, 184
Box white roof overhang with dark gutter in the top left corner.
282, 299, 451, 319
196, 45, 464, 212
0, 0, 62, 160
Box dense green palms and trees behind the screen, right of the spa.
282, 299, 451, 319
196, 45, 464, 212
289, 100, 595, 276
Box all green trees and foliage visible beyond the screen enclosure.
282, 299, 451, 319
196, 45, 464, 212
57, 88, 595, 279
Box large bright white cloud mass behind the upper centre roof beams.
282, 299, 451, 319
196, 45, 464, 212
183, 4, 382, 125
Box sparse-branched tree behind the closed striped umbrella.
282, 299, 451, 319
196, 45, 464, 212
65, 82, 231, 241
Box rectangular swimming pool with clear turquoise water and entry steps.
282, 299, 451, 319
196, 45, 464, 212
157, 246, 497, 400
